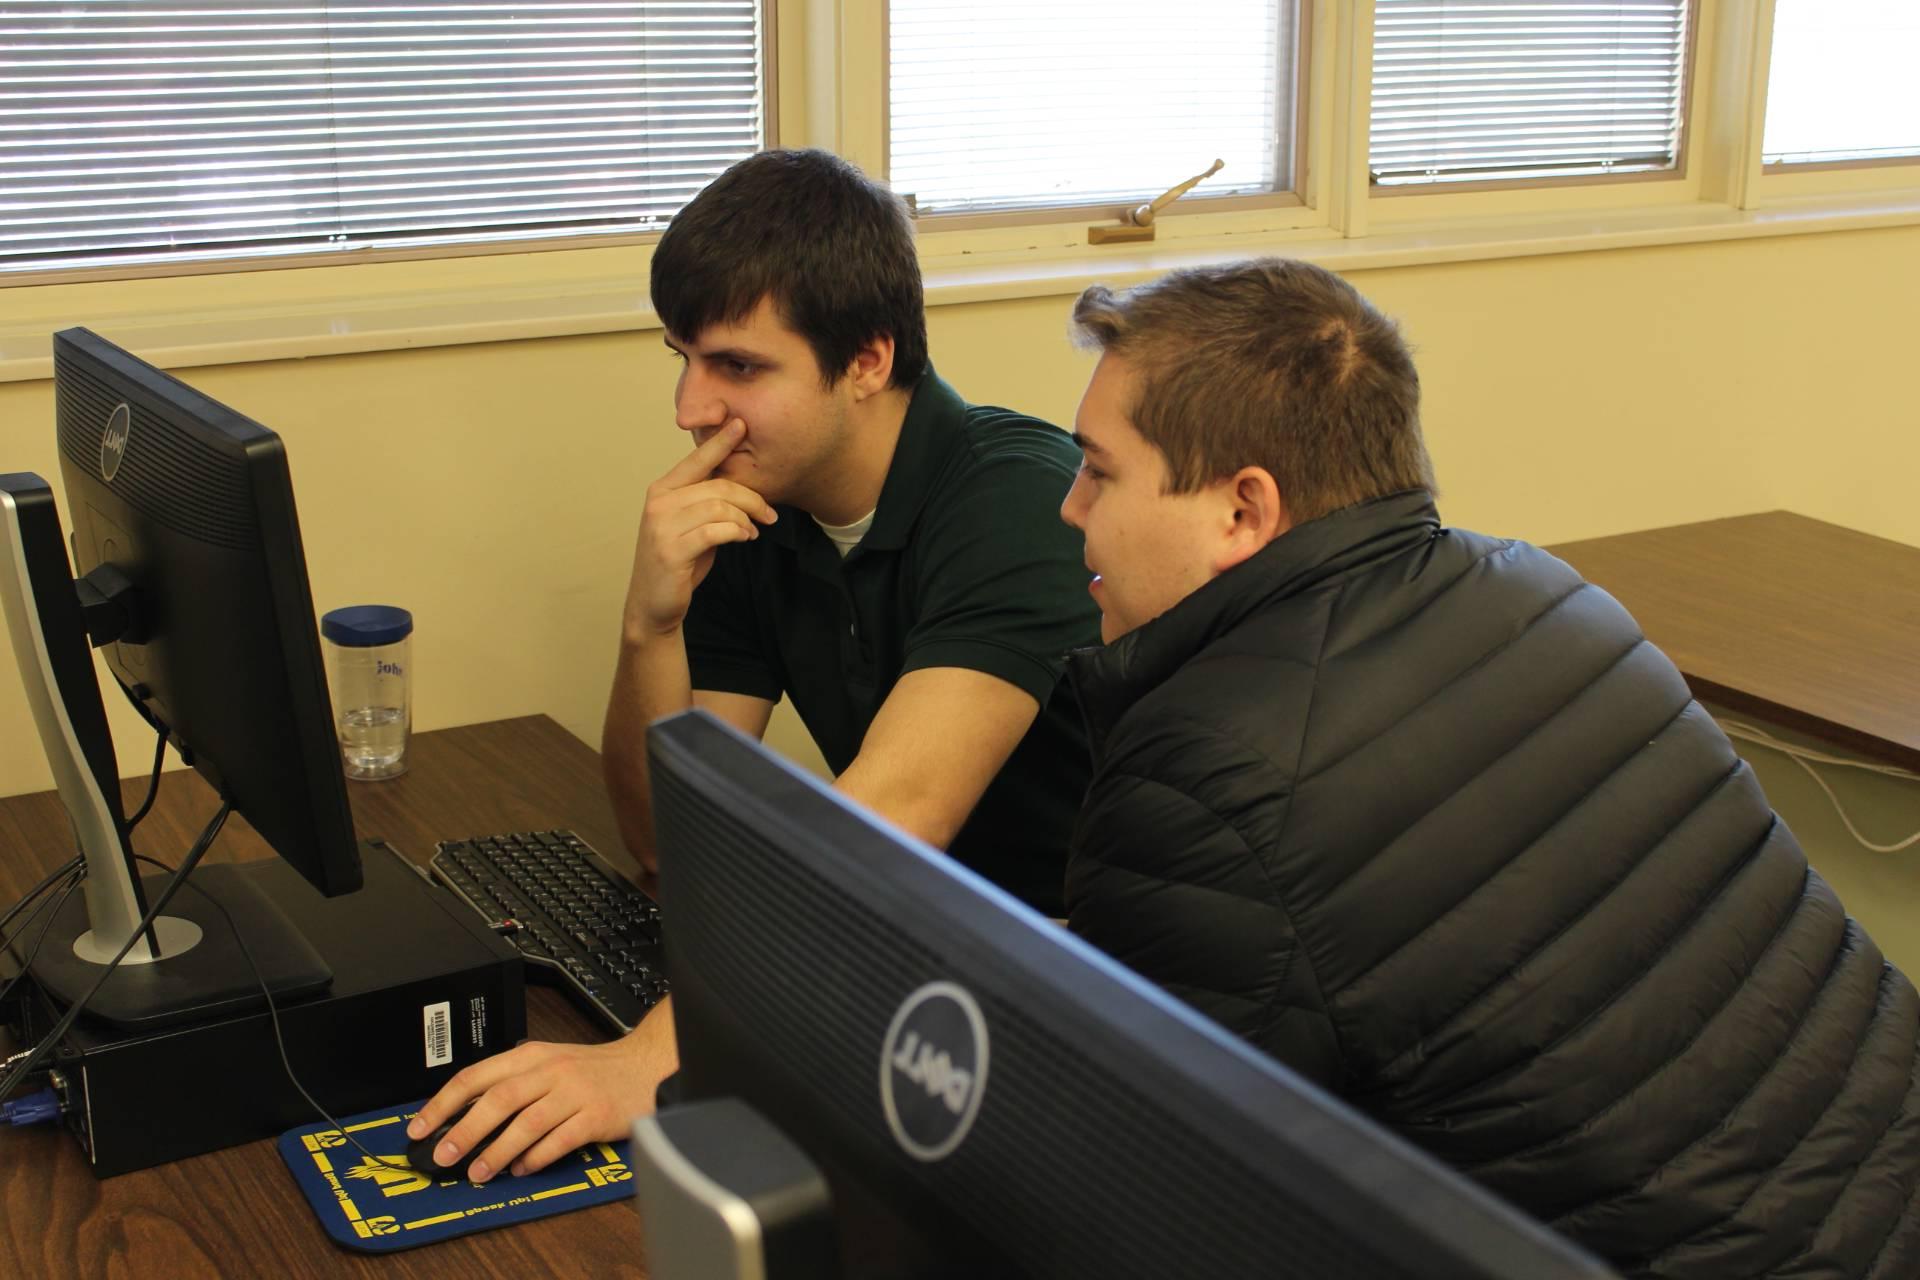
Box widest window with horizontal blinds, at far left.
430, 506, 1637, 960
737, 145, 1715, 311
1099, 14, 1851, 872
0, 0, 764, 271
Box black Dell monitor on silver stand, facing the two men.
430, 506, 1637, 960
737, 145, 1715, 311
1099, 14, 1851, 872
0, 328, 361, 1027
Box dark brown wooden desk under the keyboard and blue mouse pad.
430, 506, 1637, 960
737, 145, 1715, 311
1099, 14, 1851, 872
0, 716, 645, 1280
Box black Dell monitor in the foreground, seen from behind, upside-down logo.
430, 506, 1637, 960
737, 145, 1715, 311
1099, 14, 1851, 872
647, 712, 1611, 1280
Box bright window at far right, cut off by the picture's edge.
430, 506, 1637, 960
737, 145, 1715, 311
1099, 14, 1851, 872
1761, 0, 1920, 165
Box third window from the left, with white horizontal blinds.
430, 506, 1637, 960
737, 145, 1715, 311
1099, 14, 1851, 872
1369, 0, 1688, 186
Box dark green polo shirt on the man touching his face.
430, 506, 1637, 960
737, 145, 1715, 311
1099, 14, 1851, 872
684, 370, 1100, 915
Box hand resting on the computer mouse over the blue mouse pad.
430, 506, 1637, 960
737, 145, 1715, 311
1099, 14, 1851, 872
407, 1002, 680, 1182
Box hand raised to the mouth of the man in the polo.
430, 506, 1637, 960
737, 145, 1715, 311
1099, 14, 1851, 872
626, 418, 778, 635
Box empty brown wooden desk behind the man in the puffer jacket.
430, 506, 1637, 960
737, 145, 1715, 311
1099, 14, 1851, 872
1548, 510, 1920, 770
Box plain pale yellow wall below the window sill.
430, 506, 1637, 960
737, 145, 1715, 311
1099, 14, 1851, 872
0, 228, 1920, 958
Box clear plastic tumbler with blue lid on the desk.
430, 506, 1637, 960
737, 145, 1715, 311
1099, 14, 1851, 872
321, 604, 413, 781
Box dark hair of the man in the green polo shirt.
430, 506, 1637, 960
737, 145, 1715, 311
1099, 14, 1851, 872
649, 150, 927, 388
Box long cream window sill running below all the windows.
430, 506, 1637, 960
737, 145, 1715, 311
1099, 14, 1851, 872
0, 188, 1920, 382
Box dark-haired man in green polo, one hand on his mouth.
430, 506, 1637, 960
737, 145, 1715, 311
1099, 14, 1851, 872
409, 152, 1100, 1180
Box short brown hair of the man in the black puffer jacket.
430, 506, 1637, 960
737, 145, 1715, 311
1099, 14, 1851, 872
1073, 257, 1434, 524
